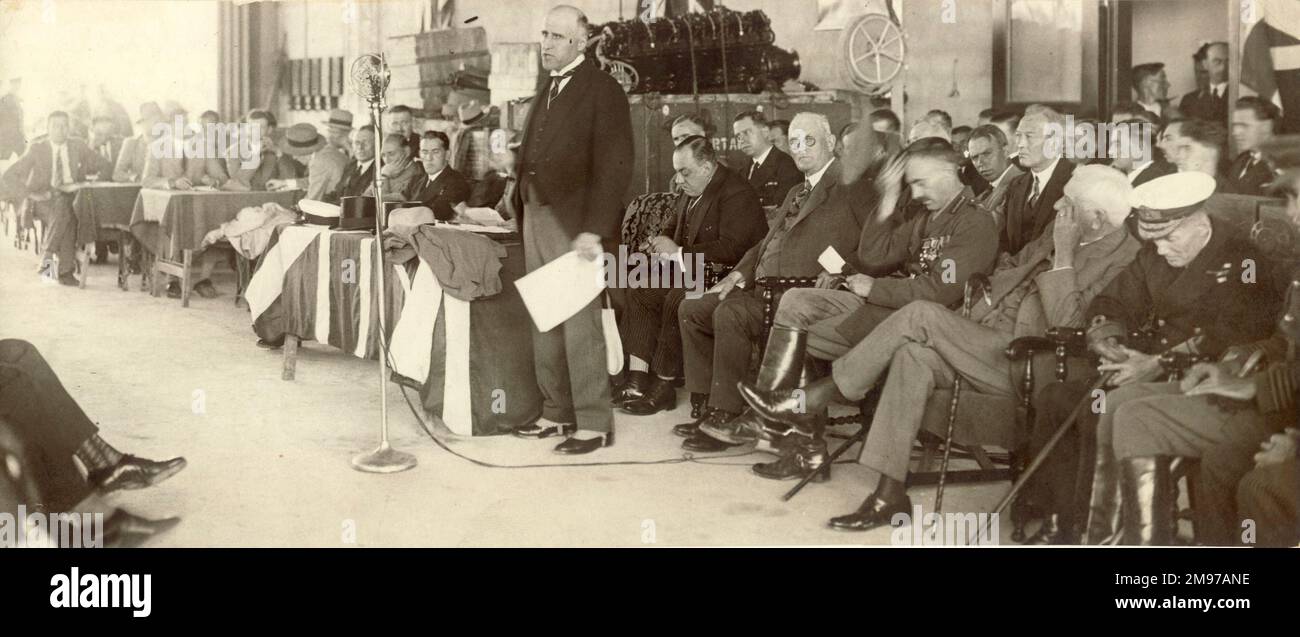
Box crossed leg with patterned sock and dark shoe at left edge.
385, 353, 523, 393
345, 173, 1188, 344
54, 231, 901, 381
0, 339, 186, 511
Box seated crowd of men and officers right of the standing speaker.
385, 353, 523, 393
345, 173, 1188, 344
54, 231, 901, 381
612, 77, 1300, 545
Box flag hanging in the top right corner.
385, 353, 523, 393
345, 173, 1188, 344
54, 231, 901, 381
1242, 0, 1300, 133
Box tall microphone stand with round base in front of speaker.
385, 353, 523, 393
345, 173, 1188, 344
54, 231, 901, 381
352, 55, 416, 473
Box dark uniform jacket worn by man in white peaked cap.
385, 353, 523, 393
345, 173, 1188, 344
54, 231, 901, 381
1087, 217, 1281, 358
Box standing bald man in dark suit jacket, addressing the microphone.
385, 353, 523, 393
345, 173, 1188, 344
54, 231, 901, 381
511, 5, 633, 454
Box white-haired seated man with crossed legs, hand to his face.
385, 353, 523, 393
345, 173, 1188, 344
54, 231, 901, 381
742, 166, 1139, 506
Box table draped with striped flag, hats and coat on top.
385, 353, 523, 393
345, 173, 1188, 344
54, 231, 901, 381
246, 220, 542, 436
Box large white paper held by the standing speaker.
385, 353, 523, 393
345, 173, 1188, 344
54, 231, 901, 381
515, 252, 605, 332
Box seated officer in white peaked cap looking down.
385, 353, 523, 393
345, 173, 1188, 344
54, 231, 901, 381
1031, 172, 1281, 543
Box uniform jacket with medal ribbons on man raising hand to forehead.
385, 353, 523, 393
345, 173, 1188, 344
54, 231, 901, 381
836, 189, 998, 343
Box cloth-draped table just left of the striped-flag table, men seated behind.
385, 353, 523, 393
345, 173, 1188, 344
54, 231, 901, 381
130, 189, 303, 307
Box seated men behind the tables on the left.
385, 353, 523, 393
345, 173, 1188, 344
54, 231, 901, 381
0, 101, 515, 298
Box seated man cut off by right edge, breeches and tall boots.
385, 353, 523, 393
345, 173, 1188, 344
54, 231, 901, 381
1113, 137, 1300, 545
